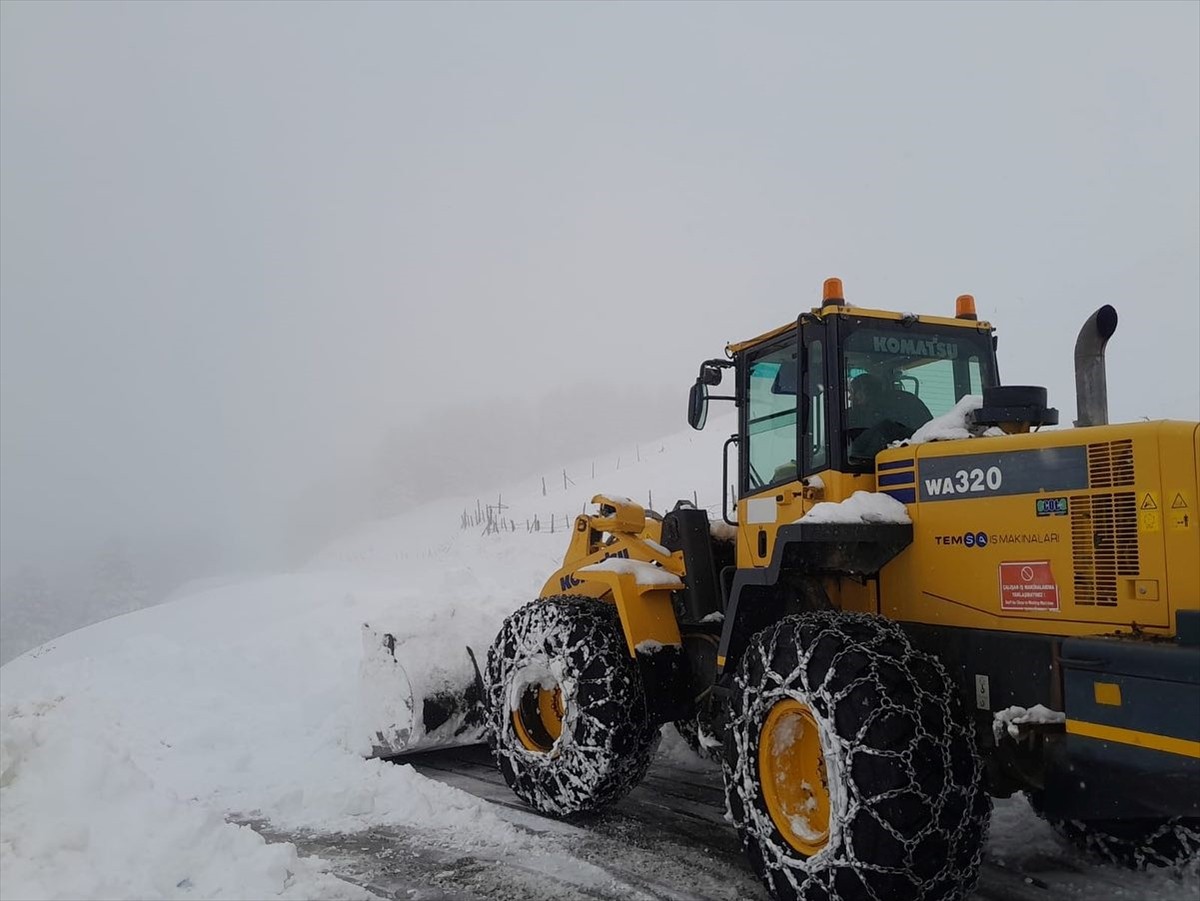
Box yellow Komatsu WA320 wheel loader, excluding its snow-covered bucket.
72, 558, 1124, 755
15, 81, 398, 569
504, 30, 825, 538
379, 280, 1200, 901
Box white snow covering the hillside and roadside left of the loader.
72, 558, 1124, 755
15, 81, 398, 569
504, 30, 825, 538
0, 418, 1198, 899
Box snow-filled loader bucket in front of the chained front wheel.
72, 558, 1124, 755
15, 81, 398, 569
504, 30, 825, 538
356, 624, 485, 757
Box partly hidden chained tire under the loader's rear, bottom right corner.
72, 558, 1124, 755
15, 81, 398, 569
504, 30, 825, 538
1028, 792, 1200, 870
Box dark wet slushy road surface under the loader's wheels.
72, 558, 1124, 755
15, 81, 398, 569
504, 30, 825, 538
250, 729, 1200, 901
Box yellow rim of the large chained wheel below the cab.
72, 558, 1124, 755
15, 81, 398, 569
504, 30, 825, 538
758, 698, 829, 857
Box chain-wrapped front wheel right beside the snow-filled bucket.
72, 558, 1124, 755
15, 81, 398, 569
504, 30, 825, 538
485, 596, 659, 816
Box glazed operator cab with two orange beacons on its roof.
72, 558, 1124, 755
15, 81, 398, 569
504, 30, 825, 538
689, 280, 998, 497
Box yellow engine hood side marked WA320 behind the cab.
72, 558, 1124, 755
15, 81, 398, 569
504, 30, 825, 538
877, 422, 1200, 635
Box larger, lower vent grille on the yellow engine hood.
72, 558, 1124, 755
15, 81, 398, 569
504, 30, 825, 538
1070, 494, 1140, 607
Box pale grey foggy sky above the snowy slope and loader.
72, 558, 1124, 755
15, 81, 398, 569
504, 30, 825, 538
0, 1, 1200, 656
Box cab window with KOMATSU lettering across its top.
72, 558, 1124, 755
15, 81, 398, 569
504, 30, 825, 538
842, 320, 996, 465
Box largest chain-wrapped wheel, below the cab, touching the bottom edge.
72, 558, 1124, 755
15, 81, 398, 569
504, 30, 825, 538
724, 611, 991, 901
